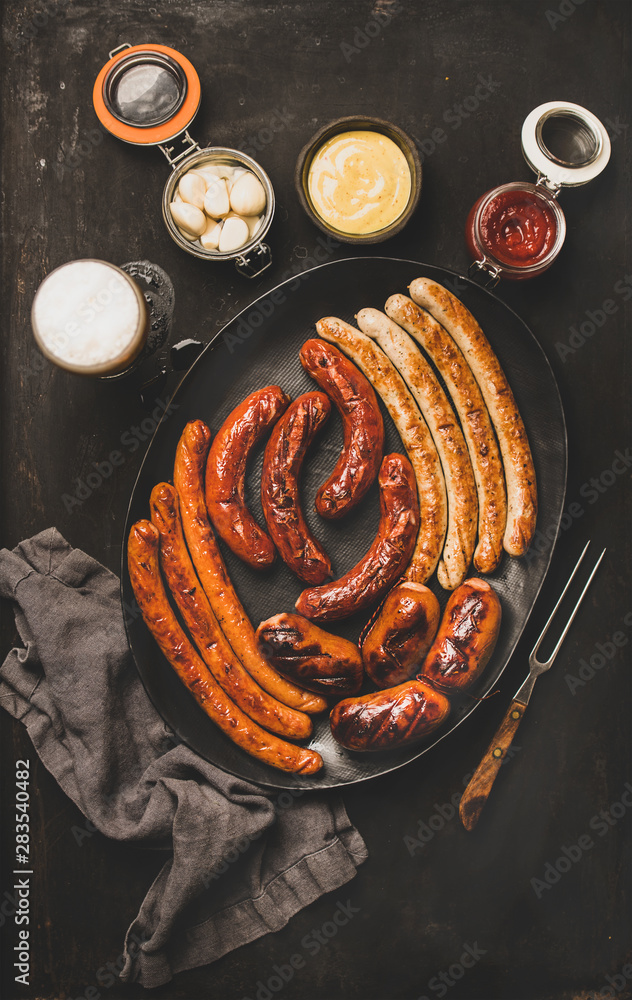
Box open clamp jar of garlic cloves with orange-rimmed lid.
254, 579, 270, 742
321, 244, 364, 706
93, 43, 274, 278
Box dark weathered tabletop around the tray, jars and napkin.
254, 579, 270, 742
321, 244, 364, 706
0, 0, 632, 1000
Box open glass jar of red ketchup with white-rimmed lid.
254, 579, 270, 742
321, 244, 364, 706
465, 101, 610, 286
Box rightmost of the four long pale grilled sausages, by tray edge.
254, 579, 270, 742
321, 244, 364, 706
410, 278, 538, 556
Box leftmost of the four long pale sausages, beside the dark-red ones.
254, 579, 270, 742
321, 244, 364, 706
316, 317, 448, 583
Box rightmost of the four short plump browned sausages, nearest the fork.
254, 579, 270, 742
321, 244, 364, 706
417, 577, 502, 694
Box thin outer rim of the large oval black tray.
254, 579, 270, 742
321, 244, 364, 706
119, 254, 568, 792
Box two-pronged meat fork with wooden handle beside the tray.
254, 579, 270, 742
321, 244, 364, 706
459, 542, 606, 830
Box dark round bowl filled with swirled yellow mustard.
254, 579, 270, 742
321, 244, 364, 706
294, 115, 421, 243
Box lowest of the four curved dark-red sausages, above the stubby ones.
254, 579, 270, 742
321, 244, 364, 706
295, 454, 419, 621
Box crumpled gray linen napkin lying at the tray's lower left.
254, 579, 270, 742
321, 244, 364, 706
0, 528, 367, 987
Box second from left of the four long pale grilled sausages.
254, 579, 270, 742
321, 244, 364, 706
356, 309, 478, 590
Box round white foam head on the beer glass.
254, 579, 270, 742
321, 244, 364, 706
32, 260, 142, 369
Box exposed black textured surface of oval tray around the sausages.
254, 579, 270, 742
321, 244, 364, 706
121, 257, 566, 789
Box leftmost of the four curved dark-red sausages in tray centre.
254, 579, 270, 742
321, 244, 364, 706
206, 385, 290, 569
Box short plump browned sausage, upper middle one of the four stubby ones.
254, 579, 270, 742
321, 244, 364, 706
362, 580, 441, 688
